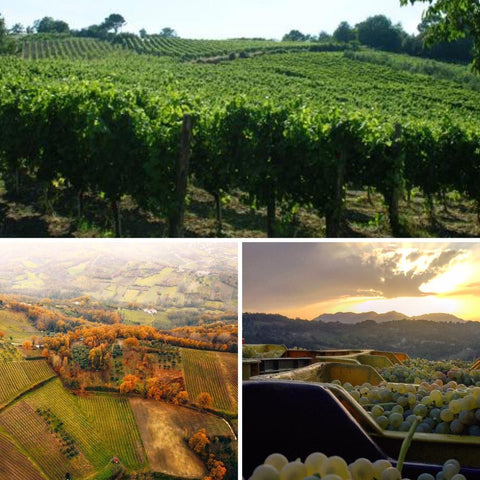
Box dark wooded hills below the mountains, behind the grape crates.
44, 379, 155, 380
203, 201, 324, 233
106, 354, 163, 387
243, 313, 480, 361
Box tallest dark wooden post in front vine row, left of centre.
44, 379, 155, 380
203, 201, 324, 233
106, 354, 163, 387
169, 114, 194, 238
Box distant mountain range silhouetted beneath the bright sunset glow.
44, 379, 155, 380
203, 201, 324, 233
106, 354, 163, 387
312, 311, 465, 325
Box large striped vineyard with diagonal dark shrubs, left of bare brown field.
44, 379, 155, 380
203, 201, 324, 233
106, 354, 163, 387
0, 380, 148, 478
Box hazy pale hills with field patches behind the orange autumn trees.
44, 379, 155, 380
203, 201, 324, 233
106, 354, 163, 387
0, 242, 237, 312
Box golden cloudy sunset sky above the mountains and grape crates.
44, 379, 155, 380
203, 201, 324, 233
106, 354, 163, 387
242, 241, 480, 321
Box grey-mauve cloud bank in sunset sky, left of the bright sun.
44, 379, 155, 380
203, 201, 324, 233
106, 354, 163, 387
243, 242, 469, 311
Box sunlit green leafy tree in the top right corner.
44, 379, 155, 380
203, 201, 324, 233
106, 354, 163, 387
400, 0, 480, 73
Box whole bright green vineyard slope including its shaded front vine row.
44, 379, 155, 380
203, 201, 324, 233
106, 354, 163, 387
0, 44, 480, 237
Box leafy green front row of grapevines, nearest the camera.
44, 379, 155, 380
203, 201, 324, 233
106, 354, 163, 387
0, 77, 480, 236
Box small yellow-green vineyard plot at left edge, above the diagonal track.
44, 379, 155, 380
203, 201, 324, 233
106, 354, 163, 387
0, 360, 55, 405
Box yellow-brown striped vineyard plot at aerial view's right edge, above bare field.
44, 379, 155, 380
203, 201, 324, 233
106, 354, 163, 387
181, 348, 238, 413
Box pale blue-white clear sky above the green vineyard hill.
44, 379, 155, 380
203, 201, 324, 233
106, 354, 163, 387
0, 0, 425, 39
